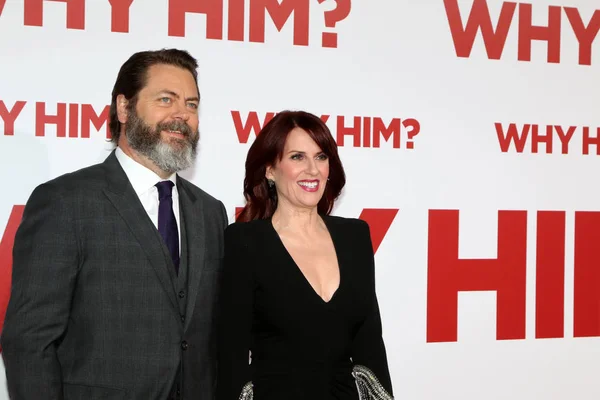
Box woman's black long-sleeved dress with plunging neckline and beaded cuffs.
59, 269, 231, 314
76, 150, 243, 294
217, 216, 392, 400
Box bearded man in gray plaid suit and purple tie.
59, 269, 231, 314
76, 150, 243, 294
2, 49, 228, 400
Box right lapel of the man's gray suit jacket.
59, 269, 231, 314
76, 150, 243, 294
177, 177, 206, 331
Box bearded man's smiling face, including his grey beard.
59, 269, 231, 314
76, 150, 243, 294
125, 64, 199, 174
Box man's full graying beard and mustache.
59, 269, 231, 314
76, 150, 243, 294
125, 109, 200, 174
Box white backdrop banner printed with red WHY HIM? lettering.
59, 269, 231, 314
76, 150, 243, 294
0, 0, 600, 400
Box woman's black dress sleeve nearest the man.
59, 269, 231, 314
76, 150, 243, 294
217, 224, 254, 400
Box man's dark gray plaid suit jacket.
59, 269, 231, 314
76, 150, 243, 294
2, 152, 228, 400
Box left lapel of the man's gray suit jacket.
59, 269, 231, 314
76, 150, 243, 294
104, 151, 179, 310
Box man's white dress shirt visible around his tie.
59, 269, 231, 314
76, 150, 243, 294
115, 147, 181, 255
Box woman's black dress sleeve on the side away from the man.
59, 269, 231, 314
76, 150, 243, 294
352, 221, 393, 400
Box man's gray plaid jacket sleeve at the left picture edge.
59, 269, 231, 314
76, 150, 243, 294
2, 184, 79, 400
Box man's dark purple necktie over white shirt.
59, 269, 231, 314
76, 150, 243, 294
155, 181, 179, 273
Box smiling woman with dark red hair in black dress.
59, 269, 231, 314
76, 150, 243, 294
217, 111, 393, 400
